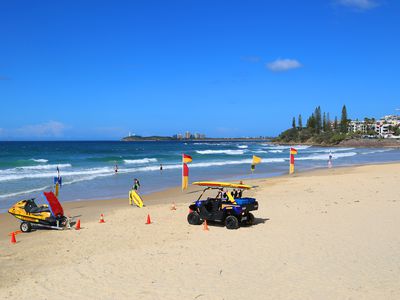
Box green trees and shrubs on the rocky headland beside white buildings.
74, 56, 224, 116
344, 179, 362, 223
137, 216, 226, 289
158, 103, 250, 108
274, 105, 355, 145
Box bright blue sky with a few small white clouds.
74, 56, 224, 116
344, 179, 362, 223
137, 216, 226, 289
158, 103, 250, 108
0, 0, 400, 140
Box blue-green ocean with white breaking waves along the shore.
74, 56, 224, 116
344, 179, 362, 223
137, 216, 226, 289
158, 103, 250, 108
0, 141, 400, 212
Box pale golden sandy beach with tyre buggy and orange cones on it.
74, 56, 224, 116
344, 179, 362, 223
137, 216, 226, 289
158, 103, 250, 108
0, 164, 400, 299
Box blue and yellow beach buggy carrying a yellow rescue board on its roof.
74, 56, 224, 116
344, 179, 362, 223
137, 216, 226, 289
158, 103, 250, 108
187, 181, 258, 229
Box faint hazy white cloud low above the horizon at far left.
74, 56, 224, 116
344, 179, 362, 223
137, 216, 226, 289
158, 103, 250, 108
15, 121, 67, 138
